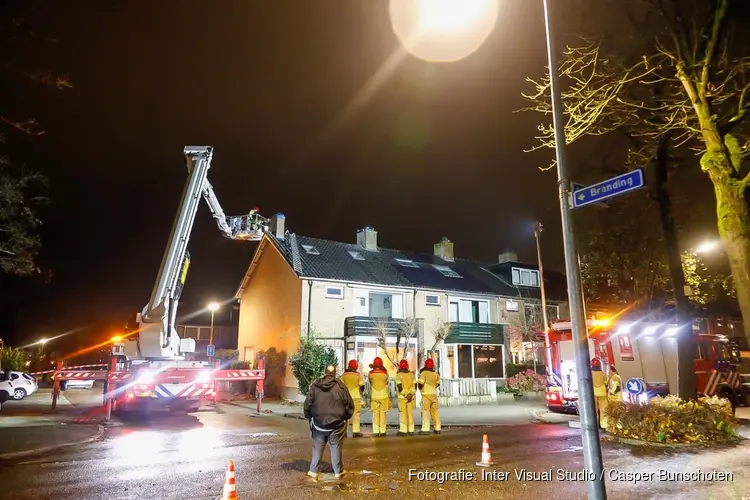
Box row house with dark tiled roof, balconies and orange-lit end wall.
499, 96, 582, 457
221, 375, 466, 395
235, 214, 564, 398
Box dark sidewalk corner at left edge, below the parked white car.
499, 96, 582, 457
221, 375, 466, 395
0, 390, 104, 460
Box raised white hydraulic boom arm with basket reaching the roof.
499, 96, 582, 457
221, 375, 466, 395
137, 146, 268, 359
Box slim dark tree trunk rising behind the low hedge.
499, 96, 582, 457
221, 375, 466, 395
651, 135, 696, 399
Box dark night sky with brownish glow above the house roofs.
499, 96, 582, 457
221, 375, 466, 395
2, 0, 728, 346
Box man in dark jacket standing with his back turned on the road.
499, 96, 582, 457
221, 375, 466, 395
305, 365, 354, 479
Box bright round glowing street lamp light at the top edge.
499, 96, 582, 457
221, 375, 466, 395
389, 0, 499, 62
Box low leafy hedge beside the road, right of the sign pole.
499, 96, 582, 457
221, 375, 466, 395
607, 396, 738, 443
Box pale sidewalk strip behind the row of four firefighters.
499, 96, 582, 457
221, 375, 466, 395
222, 401, 570, 427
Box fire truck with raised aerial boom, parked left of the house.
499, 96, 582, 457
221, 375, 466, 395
109, 146, 269, 413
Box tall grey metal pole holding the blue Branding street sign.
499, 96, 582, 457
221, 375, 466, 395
542, 0, 607, 500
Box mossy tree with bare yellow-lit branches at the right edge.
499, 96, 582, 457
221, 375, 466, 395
527, 0, 750, 397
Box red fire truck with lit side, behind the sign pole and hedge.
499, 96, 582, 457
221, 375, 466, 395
546, 318, 745, 413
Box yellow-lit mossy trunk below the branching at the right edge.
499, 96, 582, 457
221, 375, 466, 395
711, 175, 750, 343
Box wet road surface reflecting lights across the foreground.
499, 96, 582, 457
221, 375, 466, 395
0, 396, 750, 500
